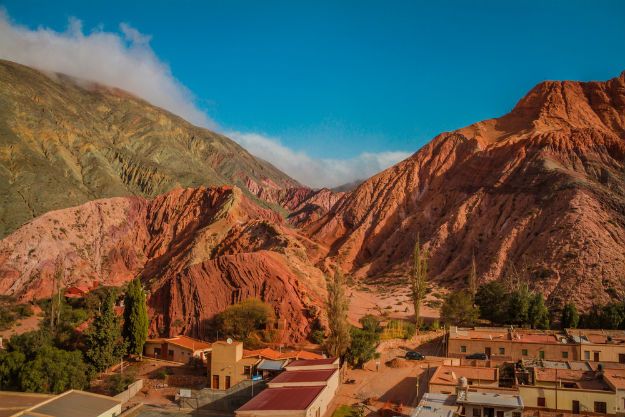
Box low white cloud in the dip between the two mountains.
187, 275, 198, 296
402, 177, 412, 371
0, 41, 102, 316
225, 132, 410, 188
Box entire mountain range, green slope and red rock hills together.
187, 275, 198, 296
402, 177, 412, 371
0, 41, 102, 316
0, 62, 625, 341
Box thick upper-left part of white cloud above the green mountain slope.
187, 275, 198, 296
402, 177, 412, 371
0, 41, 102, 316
0, 9, 215, 128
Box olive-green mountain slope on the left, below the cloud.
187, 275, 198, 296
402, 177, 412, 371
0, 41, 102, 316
0, 60, 299, 238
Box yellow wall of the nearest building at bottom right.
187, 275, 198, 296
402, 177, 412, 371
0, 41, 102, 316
519, 385, 617, 414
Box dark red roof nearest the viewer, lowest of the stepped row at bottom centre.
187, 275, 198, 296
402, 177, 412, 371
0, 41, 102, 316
236, 386, 325, 411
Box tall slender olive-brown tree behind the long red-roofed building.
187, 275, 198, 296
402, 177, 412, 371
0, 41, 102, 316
326, 270, 351, 357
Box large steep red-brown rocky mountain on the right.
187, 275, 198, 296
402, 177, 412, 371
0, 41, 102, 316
305, 73, 625, 307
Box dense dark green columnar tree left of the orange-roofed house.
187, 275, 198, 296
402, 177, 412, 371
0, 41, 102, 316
122, 277, 149, 356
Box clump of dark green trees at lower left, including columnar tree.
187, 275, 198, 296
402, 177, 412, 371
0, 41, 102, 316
0, 278, 148, 393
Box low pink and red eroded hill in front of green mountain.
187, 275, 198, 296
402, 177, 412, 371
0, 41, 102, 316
0, 186, 325, 341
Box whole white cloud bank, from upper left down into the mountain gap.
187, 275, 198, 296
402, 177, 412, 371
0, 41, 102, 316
0, 8, 409, 187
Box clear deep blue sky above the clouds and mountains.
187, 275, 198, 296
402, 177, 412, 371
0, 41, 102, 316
0, 0, 625, 185
